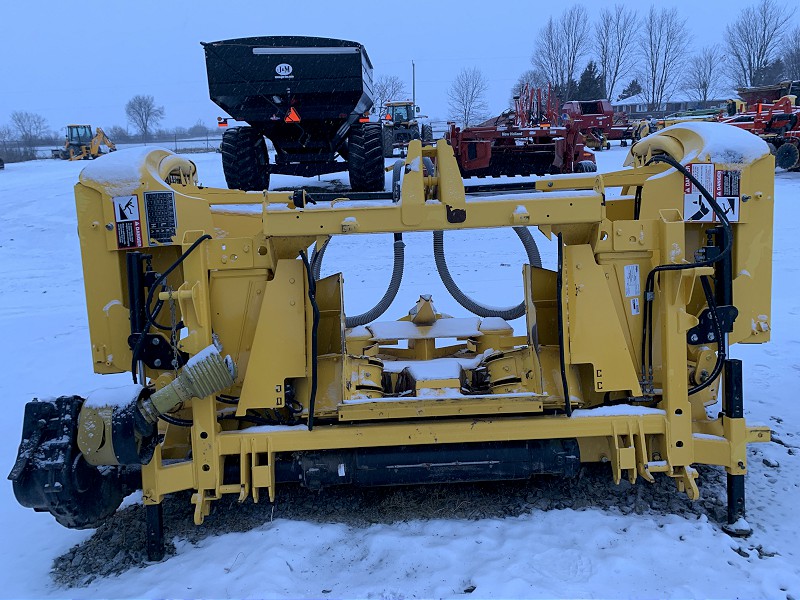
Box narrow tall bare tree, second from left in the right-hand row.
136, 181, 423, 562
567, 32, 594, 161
594, 4, 638, 99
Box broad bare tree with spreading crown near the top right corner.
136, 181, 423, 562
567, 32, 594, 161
724, 0, 797, 87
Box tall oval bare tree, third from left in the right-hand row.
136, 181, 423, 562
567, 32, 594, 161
637, 6, 689, 110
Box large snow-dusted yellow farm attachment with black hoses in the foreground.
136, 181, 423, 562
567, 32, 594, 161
9, 123, 774, 559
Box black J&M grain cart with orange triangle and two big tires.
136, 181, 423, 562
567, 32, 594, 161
203, 36, 384, 192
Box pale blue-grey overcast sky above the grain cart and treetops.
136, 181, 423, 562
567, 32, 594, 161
0, 0, 744, 131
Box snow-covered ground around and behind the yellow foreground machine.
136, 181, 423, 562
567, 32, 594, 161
0, 147, 800, 599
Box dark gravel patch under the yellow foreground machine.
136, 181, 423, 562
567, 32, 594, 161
51, 465, 727, 588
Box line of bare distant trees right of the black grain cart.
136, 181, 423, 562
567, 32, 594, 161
434, 0, 800, 126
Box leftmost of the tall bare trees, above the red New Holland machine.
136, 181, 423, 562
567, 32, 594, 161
531, 4, 589, 100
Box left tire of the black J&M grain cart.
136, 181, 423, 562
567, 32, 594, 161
221, 127, 269, 192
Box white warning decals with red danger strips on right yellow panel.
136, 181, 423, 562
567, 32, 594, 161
683, 163, 741, 223
